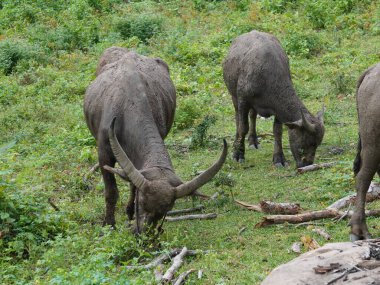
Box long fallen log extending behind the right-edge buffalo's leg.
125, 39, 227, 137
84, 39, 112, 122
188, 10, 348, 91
255, 209, 380, 228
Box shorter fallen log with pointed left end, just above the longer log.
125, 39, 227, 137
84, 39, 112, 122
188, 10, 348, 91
235, 200, 301, 215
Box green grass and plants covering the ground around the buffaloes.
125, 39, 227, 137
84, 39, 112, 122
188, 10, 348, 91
0, 0, 380, 284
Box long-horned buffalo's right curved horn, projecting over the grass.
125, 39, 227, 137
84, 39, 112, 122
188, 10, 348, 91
175, 139, 228, 198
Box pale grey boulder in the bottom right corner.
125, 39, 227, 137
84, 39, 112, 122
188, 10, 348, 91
261, 239, 380, 285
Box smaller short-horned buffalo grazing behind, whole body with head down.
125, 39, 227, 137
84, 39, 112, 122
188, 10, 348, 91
223, 31, 324, 167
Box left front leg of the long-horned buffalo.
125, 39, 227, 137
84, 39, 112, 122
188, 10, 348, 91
98, 140, 119, 227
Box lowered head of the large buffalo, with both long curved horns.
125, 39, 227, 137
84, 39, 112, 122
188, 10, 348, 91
108, 118, 227, 234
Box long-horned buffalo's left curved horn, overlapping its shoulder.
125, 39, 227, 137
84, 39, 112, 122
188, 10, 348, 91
108, 117, 147, 189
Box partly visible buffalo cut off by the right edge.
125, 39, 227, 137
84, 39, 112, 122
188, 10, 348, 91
350, 63, 380, 240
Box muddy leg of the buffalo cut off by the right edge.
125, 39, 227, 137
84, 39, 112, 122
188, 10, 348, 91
350, 149, 380, 241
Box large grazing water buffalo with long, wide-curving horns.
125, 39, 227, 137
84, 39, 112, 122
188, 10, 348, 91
84, 47, 227, 234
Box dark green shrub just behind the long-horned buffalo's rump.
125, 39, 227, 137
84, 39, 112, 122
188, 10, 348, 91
115, 14, 163, 42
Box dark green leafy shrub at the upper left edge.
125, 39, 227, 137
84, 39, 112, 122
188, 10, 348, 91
0, 40, 42, 75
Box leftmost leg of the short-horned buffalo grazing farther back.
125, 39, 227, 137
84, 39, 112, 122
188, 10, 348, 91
233, 98, 249, 163
